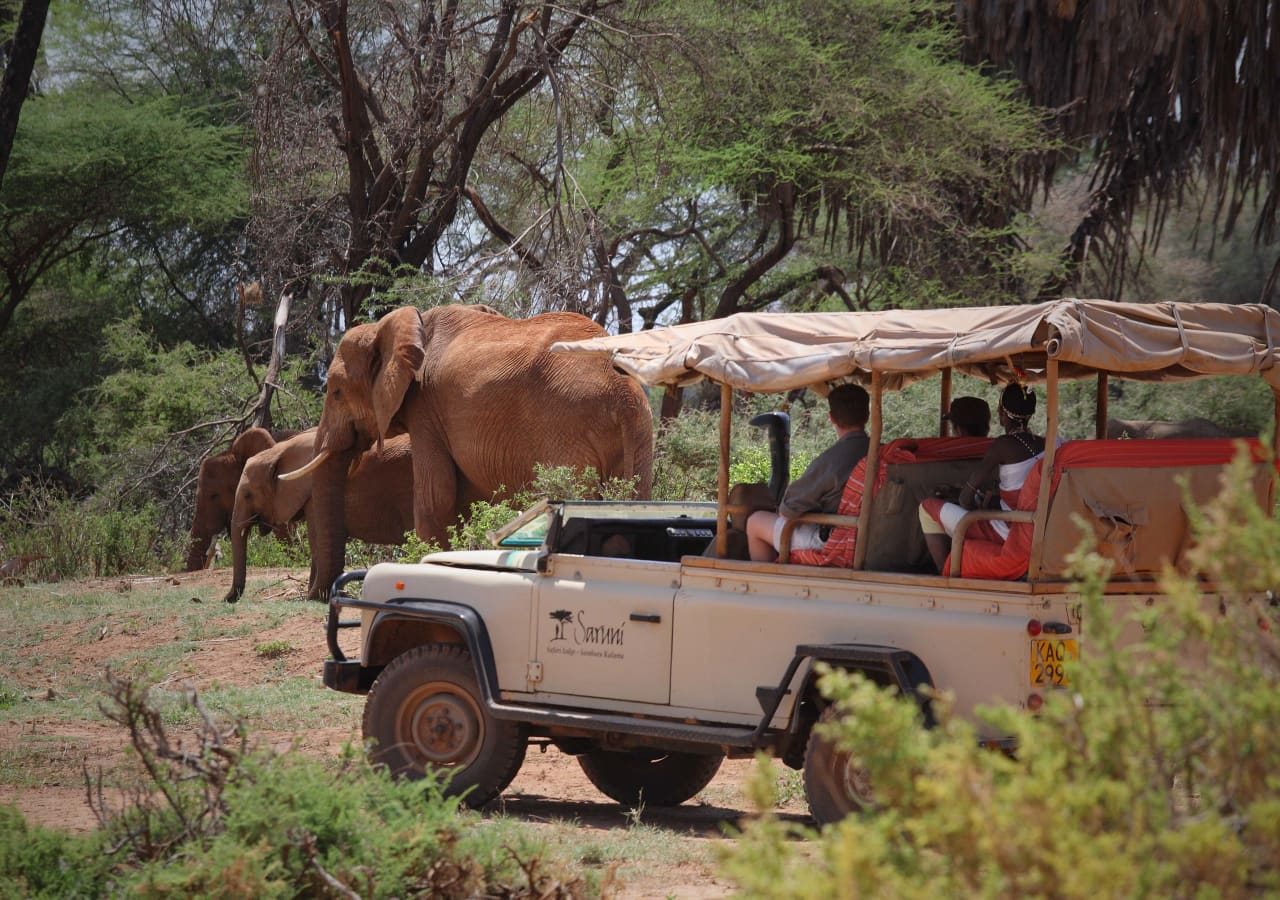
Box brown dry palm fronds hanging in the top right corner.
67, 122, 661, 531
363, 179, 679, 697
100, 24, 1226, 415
956, 0, 1280, 302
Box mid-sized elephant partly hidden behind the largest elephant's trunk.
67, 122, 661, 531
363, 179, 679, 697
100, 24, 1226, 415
224, 429, 413, 603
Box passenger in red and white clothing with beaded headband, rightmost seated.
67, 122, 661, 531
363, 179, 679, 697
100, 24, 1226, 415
920, 383, 1044, 572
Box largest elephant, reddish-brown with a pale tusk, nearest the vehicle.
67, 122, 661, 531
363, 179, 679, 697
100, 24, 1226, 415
285, 306, 653, 599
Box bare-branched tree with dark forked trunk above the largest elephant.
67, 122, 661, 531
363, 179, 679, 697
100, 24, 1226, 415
255, 0, 614, 325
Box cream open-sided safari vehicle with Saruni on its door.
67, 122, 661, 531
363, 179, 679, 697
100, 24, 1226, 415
324, 300, 1280, 822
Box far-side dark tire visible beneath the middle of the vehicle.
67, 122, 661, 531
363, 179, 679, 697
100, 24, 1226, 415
577, 750, 724, 807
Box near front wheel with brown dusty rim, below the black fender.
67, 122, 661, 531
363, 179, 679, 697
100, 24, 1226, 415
364, 644, 529, 807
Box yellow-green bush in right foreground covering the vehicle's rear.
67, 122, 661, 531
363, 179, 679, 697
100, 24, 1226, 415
727, 460, 1280, 897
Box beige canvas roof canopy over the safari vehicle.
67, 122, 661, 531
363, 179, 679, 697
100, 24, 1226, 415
552, 300, 1280, 393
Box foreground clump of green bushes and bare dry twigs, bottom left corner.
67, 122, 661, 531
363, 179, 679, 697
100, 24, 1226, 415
0, 680, 584, 899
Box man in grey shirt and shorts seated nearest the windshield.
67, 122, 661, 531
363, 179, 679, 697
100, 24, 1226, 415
746, 384, 870, 562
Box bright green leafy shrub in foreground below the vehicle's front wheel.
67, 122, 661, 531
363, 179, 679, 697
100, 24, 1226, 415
124, 754, 573, 897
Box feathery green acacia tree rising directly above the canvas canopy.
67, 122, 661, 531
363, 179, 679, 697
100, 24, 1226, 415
455, 0, 1048, 330
